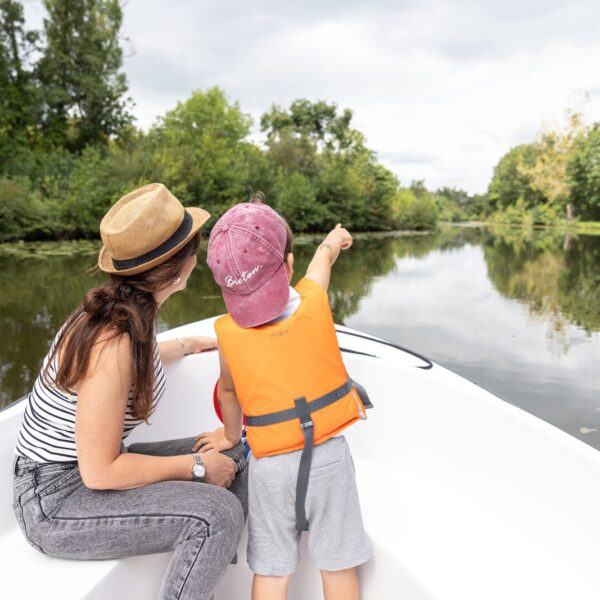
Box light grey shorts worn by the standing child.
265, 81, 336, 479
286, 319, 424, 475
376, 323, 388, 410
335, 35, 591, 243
247, 436, 371, 576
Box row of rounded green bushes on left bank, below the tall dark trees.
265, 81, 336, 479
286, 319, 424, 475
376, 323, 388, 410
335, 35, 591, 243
0, 88, 440, 239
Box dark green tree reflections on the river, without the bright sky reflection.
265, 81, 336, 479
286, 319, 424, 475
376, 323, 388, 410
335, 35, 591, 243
0, 227, 600, 406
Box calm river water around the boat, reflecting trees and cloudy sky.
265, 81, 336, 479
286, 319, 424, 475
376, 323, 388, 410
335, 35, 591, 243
0, 226, 600, 449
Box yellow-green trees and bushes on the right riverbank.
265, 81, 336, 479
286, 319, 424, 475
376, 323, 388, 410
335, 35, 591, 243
418, 110, 600, 234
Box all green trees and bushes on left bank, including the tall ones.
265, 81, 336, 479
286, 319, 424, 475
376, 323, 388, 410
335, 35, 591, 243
0, 0, 446, 241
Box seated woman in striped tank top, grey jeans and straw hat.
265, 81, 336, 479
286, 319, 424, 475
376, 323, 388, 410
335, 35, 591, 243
14, 184, 247, 600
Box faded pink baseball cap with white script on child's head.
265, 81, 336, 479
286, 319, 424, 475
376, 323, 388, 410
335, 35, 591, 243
206, 202, 290, 327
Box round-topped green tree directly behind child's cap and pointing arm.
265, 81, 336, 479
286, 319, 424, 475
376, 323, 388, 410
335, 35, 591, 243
261, 99, 398, 231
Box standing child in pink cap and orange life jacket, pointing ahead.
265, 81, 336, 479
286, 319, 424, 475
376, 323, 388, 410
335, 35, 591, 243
199, 203, 371, 600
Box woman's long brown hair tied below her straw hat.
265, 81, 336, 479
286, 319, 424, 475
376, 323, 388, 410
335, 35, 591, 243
43, 232, 201, 420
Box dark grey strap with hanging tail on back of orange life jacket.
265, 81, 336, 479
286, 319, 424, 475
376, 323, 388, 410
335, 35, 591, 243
246, 378, 373, 531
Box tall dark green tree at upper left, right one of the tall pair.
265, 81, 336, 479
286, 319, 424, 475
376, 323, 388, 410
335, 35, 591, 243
38, 0, 132, 151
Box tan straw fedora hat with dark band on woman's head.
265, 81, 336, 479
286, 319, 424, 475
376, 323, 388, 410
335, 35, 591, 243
98, 183, 210, 275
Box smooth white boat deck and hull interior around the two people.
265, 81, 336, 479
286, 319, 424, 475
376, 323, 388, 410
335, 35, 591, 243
0, 320, 600, 600
